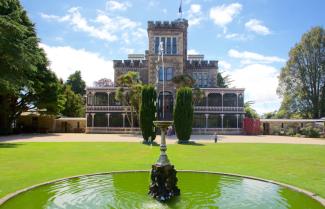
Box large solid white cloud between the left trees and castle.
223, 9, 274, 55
40, 44, 114, 86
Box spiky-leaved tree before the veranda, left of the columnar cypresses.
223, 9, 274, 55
115, 71, 142, 127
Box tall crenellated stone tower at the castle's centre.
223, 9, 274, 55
147, 19, 188, 93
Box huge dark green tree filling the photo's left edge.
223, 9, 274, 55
0, 0, 64, 134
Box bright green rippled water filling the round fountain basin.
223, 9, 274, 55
0, 172, 324, 209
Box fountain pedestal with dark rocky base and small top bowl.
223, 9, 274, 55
149, 121, 180, 201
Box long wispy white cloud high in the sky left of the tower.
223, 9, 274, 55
41, 7, 141, 42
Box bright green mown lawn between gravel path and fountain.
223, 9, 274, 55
0, 142, 325, 197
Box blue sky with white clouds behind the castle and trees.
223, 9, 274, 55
22, 0, 325, 113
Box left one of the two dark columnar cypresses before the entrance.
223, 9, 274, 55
140, 85, 157, 141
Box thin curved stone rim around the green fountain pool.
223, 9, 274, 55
0, 170, 325, 207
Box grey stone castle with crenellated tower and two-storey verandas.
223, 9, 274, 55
86, 19, 245, 134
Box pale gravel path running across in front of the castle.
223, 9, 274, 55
0, 133, 325, 145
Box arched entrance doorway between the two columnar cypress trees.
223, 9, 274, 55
158, 91, 174, 120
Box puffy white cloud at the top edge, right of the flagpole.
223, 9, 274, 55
209, 3, 242, 28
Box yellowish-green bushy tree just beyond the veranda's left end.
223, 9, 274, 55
61, 85, 85, 117
